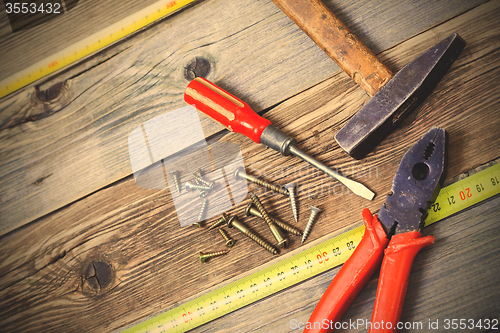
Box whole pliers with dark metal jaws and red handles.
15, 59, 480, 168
304, 127, 446, 333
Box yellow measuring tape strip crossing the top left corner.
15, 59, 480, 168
0, 0, 195, 98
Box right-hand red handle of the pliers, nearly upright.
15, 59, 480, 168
369, 231, 434, 333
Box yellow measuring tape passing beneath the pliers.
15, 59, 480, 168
125, 164, 500, 332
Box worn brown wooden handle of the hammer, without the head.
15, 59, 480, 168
273, 0, 393, 96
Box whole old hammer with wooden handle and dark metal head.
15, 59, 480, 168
273, 0, 465, 159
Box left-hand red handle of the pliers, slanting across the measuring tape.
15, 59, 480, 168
304, 209, 389, 333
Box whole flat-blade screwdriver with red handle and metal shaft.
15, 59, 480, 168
184, 77, 375, 200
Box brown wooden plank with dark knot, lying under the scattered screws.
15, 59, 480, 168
0, 1, 500, 332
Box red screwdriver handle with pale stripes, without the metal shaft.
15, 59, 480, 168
184, 77, 271, 143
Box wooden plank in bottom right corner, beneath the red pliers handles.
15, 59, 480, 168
193, 196, 500, 333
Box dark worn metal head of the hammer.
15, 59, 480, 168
335, 33, 465, 159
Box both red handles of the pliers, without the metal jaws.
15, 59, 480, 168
304, 209, 434, 333
